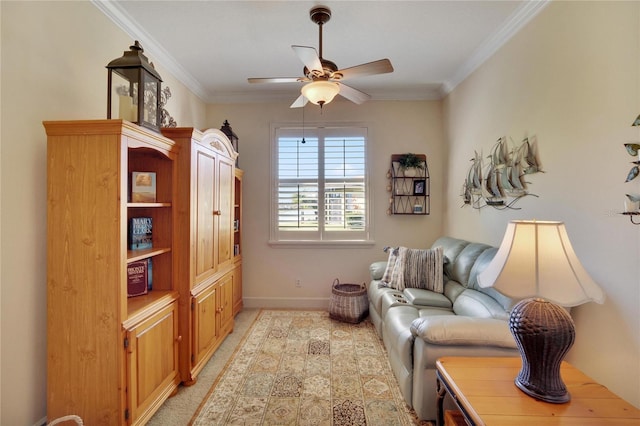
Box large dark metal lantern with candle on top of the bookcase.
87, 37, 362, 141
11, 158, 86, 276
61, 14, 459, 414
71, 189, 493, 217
107, 40, 162, 132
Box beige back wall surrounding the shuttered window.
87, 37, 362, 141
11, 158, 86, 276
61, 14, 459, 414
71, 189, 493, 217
207, 100, 445, 307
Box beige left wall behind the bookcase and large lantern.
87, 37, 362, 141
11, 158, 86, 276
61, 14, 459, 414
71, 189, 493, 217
0, 1, 205, 425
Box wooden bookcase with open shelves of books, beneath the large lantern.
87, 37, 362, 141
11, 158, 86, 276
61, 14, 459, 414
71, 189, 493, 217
43, 120, 182, 425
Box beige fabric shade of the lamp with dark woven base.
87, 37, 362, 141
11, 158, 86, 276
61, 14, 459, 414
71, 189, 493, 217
478, 220, 604, 307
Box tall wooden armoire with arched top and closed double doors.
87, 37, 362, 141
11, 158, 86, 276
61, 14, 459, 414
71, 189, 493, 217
162, 127, 242, 385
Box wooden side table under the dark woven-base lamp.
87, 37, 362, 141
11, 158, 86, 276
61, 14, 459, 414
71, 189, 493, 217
436, 357, 640, 426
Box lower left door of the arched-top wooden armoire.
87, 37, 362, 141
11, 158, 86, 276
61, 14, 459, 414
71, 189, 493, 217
191, 285, 218, 367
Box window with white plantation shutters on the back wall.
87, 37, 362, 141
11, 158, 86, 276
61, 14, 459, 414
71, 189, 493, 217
271, 127, 370, 243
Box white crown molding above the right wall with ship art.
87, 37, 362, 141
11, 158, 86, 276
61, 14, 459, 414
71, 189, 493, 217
441, 0, 551, 97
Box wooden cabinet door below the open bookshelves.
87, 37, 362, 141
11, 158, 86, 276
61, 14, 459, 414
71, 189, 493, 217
127, 301, 180, 424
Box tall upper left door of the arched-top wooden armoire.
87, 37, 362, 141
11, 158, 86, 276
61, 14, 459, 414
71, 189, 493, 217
193, 147, 217, 283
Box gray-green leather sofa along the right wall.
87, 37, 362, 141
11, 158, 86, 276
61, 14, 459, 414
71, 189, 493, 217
367, 237, 519, 420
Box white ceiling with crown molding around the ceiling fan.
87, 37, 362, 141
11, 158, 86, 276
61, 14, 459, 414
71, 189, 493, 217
93, 0, 547, 103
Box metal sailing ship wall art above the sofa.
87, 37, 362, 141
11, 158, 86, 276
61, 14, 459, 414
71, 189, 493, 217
462, 137, 542, 210
